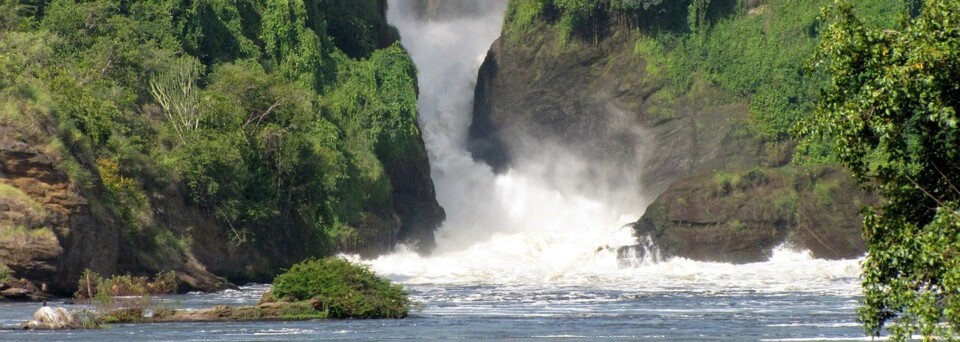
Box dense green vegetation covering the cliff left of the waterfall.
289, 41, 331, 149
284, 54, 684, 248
0, 0, 424, 260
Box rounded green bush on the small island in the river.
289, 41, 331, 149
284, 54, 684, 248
270, 257, 410, 318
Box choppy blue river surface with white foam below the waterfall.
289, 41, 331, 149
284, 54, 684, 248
0, 249, 869, 341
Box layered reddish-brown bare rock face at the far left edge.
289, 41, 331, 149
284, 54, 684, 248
0, 127, 120, 293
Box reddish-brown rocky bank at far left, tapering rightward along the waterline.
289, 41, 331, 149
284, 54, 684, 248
0, 127, 228, 300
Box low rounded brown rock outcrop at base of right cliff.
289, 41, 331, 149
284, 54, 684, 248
634, 167, 876, 263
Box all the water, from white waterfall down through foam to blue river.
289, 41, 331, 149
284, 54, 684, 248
0, 0, 869, 342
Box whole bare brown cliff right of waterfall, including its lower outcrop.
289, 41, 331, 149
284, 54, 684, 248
470, 2, 870, 262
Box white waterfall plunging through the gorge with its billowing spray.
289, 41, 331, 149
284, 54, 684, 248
350, 0, 642, 283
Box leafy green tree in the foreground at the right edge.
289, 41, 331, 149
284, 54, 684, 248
803, 0, 960, 340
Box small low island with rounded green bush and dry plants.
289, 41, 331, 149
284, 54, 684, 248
22, 257, 410, 330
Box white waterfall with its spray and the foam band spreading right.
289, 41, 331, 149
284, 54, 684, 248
365, 0, 858, 292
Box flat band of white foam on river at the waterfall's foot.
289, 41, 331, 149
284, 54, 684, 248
352, 244, 860, 295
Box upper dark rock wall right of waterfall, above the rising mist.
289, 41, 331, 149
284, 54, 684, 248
470, 15, 761, 198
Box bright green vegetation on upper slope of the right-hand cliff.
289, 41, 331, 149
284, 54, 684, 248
636, 0, 910, 146
